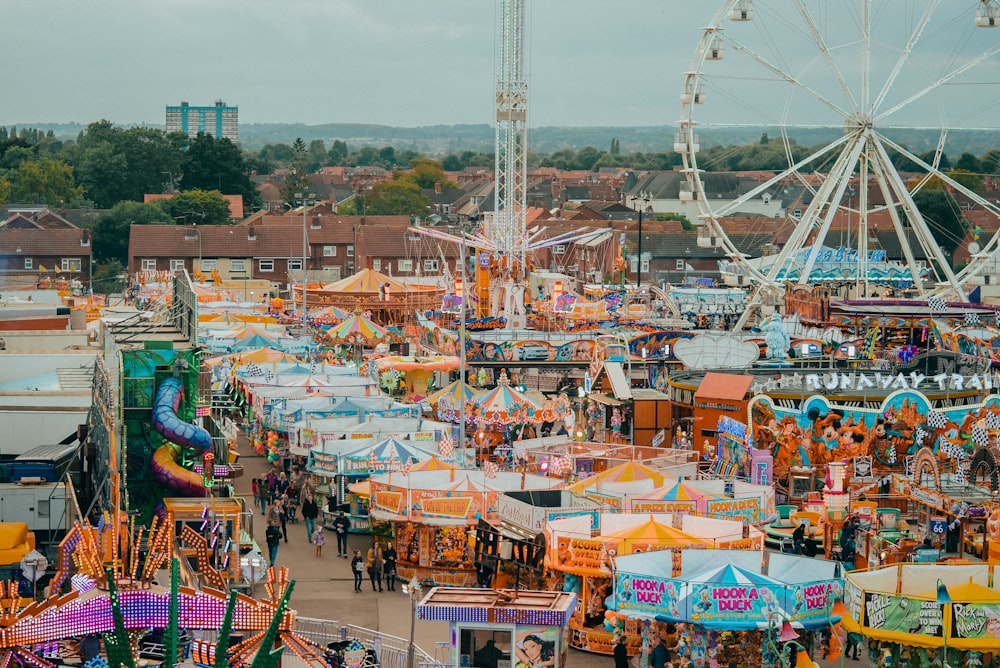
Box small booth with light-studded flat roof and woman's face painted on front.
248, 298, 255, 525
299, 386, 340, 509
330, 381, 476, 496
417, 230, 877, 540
417, 587, 576, 668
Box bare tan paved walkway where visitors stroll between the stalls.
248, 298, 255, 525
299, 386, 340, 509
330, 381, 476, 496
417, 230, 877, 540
236, 455, 852, 668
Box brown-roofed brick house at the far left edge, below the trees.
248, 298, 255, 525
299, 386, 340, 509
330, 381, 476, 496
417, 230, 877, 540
0, 207, 92, 287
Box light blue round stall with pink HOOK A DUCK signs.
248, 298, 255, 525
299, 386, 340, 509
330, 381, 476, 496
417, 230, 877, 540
611, 550, 843, 666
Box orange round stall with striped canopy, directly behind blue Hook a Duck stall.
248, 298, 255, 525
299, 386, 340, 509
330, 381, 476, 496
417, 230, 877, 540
545, 512, 764, 654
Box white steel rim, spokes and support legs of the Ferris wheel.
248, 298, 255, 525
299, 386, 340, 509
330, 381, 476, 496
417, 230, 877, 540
675, 0, 1000, 328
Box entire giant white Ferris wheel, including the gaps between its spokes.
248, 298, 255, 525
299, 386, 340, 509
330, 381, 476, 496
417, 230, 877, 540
674, 0, 1000, 329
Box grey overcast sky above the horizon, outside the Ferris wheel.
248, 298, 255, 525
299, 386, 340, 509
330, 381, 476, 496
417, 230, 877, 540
0, 0, 1000, 127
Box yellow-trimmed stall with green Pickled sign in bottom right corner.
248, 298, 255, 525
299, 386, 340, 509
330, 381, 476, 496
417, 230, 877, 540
844, 563, 1000, 666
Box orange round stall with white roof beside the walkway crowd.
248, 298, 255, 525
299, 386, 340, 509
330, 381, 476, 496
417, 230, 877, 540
370, 466, 562, 587
